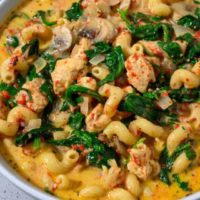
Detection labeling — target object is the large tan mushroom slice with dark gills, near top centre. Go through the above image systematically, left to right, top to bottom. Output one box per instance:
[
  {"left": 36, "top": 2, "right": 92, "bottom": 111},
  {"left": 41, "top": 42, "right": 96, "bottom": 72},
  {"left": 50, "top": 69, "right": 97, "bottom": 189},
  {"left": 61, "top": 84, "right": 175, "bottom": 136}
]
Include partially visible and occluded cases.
[{"left": 79, "top": 17, "right": 117, "bottom": 42}]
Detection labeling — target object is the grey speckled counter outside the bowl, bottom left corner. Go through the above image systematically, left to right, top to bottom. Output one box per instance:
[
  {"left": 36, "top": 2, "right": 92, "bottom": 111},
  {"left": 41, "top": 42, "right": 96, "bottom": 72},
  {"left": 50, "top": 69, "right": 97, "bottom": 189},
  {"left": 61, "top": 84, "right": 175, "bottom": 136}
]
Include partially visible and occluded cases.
[{"left": 0, "top": 174, "right": 36, "bottom": 200}]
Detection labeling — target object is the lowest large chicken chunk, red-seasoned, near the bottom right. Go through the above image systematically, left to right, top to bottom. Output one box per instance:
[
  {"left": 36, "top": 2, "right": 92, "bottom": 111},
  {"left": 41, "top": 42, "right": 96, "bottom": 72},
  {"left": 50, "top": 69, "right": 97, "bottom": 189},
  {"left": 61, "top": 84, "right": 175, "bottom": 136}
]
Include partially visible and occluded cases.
[{"left": 127, "top": 143, "right": 160, "bottom": 180}]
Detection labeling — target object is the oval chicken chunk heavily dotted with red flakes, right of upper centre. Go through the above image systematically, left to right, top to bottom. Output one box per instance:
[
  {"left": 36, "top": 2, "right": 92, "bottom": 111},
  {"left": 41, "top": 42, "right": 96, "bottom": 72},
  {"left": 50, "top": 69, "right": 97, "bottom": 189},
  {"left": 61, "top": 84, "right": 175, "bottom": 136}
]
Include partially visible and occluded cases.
[{"left": 125, "top": 54, "right": 155, "bottom": 93}]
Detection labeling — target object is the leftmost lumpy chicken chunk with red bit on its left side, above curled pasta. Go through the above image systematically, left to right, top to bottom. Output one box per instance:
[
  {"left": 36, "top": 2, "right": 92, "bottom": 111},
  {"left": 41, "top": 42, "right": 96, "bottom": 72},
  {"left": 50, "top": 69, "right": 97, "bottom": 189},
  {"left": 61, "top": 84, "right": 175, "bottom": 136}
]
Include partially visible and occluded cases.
[{"left": 16, "top": 78, "right": 48, "bottom": 113}]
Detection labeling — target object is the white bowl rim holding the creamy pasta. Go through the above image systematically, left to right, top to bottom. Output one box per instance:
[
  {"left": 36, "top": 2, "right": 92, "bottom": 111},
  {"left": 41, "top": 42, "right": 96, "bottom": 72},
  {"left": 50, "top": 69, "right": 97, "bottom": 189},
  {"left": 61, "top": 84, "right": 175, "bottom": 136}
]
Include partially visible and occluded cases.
[{"left": 0, "top": 0, "right": 200, "bottom": 200}]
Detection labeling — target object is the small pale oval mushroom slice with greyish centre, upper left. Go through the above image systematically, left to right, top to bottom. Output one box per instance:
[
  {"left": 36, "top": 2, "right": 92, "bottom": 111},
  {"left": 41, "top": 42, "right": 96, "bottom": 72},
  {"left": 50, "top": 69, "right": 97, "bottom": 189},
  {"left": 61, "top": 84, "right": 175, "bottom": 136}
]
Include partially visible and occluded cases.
[{"left": 53, "top": 25, "right": 72, "bottom": 51}]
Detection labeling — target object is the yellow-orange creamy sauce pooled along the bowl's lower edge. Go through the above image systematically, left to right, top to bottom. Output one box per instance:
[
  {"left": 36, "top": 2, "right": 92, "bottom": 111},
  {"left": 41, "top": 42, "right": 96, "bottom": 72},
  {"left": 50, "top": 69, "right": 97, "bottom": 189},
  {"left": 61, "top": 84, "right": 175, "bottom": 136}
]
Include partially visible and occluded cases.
[{"left": 0, "top": 139, "right": 200, "bottom": 200}]
